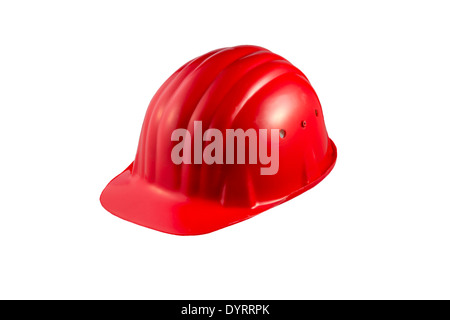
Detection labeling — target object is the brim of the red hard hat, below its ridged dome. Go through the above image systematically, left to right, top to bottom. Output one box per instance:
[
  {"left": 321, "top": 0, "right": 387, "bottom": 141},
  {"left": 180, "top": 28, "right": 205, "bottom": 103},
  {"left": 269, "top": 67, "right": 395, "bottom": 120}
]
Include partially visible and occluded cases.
[{"left": 100, "top": 139, "right": 337, "bottom": 235}]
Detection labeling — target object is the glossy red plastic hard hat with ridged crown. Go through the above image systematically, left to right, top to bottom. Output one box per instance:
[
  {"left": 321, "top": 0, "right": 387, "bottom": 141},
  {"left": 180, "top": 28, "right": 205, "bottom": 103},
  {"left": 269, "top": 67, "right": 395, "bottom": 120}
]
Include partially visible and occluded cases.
[{"left": 100, "top": 46, "right": 337, "bottom": 235}]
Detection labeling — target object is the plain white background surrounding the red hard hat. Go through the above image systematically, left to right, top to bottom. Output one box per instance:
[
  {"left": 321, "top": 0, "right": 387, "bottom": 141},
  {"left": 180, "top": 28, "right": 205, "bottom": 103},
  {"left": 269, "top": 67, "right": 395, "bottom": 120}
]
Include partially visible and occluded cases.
[{"left": 0, "top": 1, "right": 450, "bottom": 299}]
